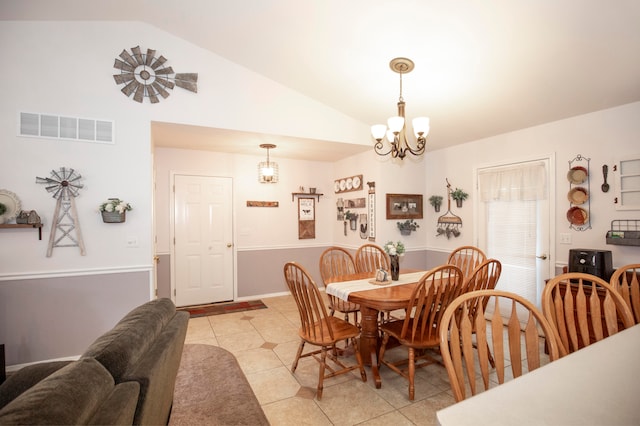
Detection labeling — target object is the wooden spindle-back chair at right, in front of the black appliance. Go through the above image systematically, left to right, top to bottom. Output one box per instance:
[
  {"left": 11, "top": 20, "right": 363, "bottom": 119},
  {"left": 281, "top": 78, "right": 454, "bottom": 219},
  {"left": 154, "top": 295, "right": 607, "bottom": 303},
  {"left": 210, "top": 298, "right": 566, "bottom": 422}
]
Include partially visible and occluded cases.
[{"left": 542, "top": 272, "right": 634, "bottom": 356}]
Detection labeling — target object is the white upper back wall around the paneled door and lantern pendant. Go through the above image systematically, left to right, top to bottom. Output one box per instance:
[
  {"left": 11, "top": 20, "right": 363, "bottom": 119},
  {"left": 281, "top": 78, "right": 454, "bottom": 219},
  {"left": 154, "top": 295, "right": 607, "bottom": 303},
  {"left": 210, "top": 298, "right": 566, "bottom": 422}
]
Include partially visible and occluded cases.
[{"left": 155, "top": 148, "right": 335, "bottom": 253}]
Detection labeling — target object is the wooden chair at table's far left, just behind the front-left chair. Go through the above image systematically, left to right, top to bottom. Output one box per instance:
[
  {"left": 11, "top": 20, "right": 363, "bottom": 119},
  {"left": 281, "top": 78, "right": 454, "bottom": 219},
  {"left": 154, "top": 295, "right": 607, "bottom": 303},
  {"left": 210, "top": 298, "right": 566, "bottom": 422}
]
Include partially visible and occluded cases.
[{"left": 319, "top": 246, "right": 360, "bottom": 324}]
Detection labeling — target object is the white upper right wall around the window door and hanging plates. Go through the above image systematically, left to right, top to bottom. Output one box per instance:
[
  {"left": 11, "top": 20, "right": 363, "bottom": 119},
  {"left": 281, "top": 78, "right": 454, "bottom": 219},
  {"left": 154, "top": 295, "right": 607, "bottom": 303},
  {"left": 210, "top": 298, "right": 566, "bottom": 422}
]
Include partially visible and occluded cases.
[{"left": 425, "top": 102, "right": 640, "bottom": 266}]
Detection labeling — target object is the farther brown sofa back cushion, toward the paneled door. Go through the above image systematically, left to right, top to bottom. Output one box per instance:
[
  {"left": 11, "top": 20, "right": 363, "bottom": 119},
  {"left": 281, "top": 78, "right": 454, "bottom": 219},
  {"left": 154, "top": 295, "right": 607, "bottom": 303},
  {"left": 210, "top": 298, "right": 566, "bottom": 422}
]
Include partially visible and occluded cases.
[{"left": 82, "top": 298, "right": 176, "bottom": 383}]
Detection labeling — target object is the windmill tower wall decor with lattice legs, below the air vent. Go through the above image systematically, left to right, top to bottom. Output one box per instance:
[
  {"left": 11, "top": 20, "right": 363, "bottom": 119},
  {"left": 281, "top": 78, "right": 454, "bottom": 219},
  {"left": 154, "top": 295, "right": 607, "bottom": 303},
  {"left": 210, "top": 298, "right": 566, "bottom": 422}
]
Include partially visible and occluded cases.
[{"left": 36, "top": 167, "right": 85, "bottom": 257}]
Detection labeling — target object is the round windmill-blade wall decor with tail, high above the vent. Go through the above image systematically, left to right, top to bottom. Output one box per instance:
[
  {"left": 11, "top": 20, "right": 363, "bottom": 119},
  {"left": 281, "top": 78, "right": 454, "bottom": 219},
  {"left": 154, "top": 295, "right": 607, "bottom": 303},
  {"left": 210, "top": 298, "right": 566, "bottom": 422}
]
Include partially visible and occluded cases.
[{"left": 113, "top": 46, "right": 198, "bottom": 104}]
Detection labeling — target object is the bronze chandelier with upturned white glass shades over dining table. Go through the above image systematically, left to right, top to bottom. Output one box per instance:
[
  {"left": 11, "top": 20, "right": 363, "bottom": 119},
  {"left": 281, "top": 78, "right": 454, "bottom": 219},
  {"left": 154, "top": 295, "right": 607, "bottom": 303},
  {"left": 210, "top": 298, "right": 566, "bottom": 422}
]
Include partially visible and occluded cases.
[{"left": 371, "top": 58, "right": 429, "bottom": 160}]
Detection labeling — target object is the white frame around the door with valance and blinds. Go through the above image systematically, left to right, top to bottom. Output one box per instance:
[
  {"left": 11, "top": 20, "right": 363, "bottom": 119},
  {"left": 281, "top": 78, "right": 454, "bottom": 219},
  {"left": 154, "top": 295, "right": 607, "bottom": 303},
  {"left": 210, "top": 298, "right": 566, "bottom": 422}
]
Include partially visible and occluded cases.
[{"left": 473, "top": 152, "right": 557, "bottom": 306}]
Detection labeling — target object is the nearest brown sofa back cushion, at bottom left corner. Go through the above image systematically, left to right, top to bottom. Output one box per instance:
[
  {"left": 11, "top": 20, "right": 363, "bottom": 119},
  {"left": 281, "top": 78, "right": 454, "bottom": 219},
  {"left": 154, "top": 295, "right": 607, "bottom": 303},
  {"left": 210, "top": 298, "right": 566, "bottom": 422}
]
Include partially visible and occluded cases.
[{"left": 0, "top": 358, "right": 139, "bottom": 425}]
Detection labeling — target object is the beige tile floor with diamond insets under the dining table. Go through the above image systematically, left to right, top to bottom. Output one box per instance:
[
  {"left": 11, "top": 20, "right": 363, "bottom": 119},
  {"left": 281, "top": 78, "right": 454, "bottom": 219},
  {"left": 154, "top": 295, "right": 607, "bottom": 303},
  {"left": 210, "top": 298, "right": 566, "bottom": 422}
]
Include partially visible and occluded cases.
[{"left": 186, "top": 296, "right": 455, "bottom": 426}]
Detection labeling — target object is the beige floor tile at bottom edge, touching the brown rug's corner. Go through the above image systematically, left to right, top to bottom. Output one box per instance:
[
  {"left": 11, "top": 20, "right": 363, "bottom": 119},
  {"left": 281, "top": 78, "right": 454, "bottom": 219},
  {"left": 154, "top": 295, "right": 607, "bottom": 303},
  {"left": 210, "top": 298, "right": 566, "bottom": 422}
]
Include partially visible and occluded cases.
[{"left": 262, "top": 398, "right": 332, "bottom": 426}]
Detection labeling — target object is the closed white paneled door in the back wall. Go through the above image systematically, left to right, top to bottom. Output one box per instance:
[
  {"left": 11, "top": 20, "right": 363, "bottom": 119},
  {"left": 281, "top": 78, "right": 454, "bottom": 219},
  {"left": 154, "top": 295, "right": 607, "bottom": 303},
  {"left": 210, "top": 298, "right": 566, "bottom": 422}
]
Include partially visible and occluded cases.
[{"left": 173, "top": 174, "right": 234, "bottom": 306}]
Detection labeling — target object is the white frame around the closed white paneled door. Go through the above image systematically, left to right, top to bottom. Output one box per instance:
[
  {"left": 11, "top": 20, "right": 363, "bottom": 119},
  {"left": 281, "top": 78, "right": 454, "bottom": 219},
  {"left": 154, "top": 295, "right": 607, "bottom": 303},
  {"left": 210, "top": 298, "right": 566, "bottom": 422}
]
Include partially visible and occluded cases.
[{"left": 169, "top": 170, "right": 238, "bottom": 304}]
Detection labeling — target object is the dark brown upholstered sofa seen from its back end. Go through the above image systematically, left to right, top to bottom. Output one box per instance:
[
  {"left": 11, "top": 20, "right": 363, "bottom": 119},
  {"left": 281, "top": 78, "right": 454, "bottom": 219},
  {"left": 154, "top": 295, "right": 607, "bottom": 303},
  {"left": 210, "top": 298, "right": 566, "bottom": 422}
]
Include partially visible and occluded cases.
[{"left": 0, "top": 299, "right": 189, "bottom": 425}]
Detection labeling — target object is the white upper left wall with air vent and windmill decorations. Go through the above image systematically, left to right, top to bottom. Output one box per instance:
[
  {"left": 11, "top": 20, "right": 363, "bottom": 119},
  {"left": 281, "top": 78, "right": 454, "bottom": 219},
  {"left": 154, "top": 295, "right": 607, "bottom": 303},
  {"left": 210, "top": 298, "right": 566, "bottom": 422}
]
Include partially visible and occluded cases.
[{"left": 0, "top": 21, "right": 367, "bottom": 279}]
